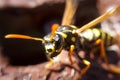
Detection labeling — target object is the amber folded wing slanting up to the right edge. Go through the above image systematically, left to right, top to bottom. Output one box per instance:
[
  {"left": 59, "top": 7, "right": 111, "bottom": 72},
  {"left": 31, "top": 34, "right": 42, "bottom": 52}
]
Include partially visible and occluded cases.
[{"left": 76, "top": 6, "right": 120, "bottom": 33}]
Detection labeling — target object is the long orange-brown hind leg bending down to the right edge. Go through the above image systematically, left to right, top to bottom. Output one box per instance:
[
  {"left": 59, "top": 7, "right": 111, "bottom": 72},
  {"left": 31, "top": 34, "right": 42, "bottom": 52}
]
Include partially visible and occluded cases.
[{"left": 95, "top": 39, "right": 120, "bottom": 74}]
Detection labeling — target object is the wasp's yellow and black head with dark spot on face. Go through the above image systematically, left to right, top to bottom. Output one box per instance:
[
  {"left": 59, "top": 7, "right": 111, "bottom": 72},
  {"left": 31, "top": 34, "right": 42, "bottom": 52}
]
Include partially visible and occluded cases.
[{"left": 44, "top": 34, "right": 64, "bottom": 58}]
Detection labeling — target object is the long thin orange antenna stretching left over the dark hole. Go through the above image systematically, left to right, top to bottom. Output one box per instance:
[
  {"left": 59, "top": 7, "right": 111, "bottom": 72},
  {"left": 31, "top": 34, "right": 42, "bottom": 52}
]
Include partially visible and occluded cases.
[{"left": 5, "top": 34, "right": 44, "bottom": 42}]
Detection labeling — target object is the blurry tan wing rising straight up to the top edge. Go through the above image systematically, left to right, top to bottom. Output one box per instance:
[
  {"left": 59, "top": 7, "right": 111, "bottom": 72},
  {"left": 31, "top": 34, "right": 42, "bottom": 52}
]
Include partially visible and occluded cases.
[{"left": 62, "top": 0, "right": 79, "bottom": 25}]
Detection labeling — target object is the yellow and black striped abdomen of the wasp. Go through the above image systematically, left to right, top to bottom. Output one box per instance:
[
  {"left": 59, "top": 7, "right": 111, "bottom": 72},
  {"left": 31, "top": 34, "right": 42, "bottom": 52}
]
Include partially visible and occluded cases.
[{"left": 80, "top": 28, "right": 114, "bottom": 47}]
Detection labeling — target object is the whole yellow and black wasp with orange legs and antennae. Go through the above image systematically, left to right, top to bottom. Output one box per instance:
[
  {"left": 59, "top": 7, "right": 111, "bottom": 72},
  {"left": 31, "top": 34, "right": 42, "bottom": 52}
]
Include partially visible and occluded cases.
[{"left": 5, "top": 0, "right": 120, "bottom": 75}]
